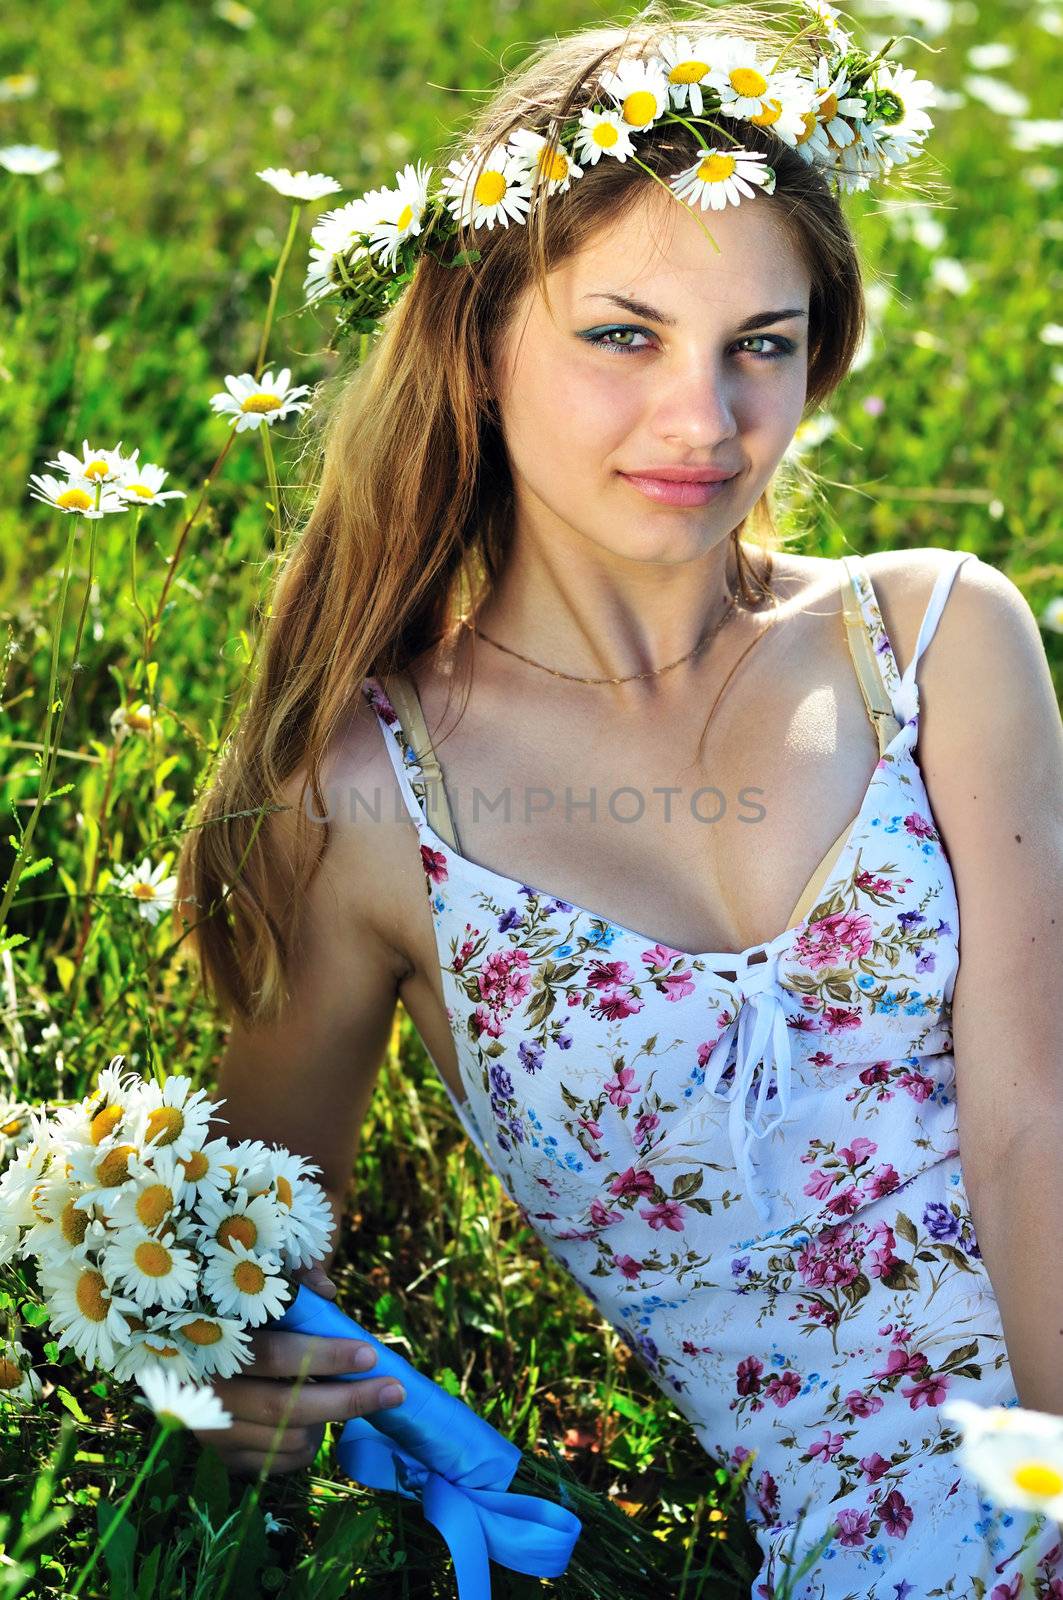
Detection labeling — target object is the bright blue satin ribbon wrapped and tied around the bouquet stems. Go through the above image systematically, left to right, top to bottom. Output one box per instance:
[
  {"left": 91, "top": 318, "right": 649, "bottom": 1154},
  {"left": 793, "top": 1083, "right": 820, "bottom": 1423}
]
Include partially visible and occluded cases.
[{"left": 269, "top": 1283, "right": 583, "bottom": 1600}]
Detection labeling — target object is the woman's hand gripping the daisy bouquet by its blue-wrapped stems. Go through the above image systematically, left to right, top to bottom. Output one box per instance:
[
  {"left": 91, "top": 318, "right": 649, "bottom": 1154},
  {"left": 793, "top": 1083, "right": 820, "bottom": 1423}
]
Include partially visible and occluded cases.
[{"left": 192, "top": 1266, "right": 405, "bottom": 1477}]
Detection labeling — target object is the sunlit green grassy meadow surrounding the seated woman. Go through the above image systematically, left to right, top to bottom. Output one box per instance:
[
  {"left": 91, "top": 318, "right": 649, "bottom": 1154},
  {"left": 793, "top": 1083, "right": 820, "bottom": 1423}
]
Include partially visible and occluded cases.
[{"left": 0, "top": 0, "right": 1063, "bottom": 1600}]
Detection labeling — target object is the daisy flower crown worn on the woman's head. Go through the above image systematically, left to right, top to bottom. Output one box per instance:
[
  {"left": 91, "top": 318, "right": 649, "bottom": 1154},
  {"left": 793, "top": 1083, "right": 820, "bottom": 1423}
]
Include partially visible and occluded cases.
[{"left": 304, "top": 0, "right": 933, "bottom": 334}]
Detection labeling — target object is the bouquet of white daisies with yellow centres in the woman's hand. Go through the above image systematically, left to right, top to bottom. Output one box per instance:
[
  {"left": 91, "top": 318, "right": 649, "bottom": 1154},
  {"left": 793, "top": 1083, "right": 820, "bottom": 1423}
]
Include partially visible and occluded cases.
[{"left": 0, "top": 1056, "right": 335, "bottom": 1382}]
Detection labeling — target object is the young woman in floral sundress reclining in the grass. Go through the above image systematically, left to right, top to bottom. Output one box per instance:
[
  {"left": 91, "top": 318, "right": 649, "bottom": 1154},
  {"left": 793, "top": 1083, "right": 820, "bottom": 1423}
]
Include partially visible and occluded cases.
[{"left": 179, "top": 6, "right": 1063, "bottom": 1600}]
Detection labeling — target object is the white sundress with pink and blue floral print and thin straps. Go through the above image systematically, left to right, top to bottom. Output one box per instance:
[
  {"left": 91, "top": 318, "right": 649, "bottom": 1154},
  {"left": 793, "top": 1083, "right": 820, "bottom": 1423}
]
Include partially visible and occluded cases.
[{"left": 362, "top": 550, "right": 1063, "bottom": 1600}]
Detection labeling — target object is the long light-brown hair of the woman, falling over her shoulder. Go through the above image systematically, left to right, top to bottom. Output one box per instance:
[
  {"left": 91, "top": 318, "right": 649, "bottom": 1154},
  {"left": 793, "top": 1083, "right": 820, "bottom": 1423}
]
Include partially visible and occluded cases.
[{"left": 178, "top": 0, "right": 864, "bottom": 1022}]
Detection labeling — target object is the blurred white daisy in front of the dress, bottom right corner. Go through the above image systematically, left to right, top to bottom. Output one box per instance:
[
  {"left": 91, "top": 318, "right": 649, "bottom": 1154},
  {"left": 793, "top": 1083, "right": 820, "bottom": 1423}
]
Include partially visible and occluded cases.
[{"left": 941, "top": 1398, "right": 1063, "bottom": 1522}]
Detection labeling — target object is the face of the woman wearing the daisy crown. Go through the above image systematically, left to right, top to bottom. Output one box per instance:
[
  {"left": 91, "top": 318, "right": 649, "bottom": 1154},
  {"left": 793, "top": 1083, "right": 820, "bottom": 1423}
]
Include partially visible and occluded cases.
[{"left": 493, "top": 187, "right": 810, "bottom": 562}]
